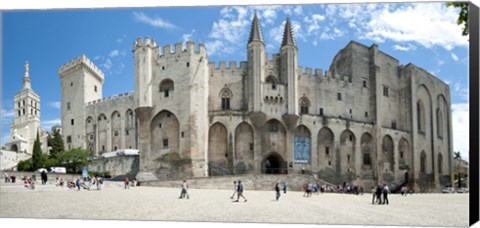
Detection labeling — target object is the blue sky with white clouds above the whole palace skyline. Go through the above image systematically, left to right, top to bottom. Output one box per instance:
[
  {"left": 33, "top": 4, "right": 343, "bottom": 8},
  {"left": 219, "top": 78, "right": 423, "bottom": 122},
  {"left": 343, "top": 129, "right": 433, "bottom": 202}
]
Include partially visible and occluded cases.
[{"left": 0, "top": 3, "right": 469, "bottom": 158}]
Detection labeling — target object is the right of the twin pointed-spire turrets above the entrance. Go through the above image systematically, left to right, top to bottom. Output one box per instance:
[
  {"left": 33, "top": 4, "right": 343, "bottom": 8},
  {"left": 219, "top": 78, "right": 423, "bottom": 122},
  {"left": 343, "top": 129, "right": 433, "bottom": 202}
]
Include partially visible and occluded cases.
[{"left": 280, "top": 17, "right": 298, "bottom": 114}]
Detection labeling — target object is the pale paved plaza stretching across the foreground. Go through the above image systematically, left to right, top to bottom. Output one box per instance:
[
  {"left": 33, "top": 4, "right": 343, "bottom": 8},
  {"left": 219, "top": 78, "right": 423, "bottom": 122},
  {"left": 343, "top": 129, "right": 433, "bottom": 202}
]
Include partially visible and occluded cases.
[{"left": 0, "top": 182, "right": 469, "bottom": 227}]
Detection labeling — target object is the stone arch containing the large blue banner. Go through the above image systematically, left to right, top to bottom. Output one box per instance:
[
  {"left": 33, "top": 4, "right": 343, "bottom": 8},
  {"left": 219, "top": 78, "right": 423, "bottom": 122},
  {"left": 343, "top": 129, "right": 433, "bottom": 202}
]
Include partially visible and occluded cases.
[{"left": 293, "top": 125, "right": 312, "bottom": 163}]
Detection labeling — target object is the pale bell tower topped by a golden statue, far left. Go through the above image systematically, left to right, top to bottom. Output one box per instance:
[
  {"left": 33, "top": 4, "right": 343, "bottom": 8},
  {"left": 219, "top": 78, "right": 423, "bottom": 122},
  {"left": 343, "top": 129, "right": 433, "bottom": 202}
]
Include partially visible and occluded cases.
[{"left": 6, "top": 62, "right": 47, "bottom": 154}]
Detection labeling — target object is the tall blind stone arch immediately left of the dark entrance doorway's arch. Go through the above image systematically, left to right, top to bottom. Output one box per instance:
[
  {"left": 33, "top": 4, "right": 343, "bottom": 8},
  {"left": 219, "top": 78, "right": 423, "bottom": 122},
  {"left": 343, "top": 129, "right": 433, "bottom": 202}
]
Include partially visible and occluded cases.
[{"left": 235, "top": 122, "right": 254, "bottom": 174}]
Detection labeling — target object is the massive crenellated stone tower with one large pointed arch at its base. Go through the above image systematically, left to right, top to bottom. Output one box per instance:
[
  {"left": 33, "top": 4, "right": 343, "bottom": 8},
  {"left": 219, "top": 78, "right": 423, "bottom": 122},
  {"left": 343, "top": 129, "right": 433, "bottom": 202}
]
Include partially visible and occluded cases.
[{"left": 134, "top": 36, "right": 208, "bottom": 180}]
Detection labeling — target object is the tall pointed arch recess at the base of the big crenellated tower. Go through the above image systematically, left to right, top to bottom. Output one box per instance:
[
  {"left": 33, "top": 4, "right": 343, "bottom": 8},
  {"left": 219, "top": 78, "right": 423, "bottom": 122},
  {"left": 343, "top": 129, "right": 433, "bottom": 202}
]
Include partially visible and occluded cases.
[{"left": 150, "top": 110, "right": 180, "bottom": 160}]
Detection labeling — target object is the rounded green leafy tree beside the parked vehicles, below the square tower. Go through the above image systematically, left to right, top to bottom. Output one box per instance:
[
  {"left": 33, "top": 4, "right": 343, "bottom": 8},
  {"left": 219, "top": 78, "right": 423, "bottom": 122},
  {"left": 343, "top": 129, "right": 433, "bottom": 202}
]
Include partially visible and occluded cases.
[{"left": 56, "top": 148, "right": 90, "bottom": 173}]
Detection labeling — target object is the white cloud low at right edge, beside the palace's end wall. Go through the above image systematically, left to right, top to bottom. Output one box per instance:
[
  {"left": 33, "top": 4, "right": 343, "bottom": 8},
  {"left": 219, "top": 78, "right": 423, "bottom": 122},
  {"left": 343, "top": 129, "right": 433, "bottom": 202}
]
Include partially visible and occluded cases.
[{"left": 452, "top": 103, "right": 470, "bottom": 160}]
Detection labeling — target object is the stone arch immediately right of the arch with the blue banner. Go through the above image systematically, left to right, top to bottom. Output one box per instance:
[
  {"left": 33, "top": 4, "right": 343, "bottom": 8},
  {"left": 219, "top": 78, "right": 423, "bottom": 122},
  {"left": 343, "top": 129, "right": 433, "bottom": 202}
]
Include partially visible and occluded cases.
[{"left": 317, "top": 127, "right": 335, "bottom": 167}]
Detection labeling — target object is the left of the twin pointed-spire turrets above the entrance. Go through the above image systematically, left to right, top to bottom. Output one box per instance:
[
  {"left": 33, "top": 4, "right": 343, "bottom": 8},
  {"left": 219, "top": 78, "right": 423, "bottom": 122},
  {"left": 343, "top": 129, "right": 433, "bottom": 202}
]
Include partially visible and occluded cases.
[{"left": 246, "top": 12, "right": 265, "bottom": 112}]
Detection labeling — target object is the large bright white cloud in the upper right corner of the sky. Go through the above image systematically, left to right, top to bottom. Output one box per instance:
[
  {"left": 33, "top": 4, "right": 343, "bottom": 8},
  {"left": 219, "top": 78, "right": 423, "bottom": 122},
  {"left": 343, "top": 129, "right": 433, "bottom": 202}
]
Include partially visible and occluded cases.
[{"left": 360, "top": 3, "right": 468, "bottom": 50}]
